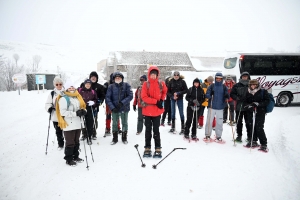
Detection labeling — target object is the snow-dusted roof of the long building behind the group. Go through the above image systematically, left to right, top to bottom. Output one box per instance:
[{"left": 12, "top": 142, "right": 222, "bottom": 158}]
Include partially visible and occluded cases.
[{"left": 107, "top": 51, "right": 193, "bottom": 67}]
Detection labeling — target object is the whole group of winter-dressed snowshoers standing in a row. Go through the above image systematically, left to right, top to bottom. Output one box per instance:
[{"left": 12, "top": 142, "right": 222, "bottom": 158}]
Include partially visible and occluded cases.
[{"left": 45, "top": 66, "right": 269, "bottom": 166}]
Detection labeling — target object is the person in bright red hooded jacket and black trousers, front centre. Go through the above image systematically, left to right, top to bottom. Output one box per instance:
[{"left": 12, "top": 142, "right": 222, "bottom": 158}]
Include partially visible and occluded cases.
[{"left": 141, "top": 66, "right": 168, "bottom": 158}]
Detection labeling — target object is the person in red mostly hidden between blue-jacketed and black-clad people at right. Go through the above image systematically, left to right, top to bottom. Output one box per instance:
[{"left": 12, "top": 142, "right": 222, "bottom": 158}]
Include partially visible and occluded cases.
[{"left": 223, "top": 76, "right": 235, "bottom": 126}]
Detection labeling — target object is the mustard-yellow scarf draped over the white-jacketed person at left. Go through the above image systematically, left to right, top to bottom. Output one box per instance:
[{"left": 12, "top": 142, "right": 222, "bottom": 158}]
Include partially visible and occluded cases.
[{"left": 55, "top": 90, "right": 86, "bottom": 129}]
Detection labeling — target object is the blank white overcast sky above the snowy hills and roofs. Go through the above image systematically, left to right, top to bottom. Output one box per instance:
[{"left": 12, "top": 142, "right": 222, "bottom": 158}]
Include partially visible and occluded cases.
[{"left": 0, "top": 0, "right": 300, "bottom": 51}]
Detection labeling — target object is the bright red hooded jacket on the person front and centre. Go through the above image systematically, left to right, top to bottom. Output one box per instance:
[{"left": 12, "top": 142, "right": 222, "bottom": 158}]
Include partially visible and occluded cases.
[{"left": 141, "top": 66, "right": 168, "bottom": 117}]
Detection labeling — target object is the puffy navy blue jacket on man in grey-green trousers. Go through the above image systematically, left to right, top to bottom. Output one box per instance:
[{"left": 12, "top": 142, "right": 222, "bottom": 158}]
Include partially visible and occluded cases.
[{"left": 105, "top": 81, "right": 133, "bottom": 112}]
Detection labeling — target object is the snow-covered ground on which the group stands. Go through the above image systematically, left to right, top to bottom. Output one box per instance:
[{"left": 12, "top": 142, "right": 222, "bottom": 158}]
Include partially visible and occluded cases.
[{"left": 0, "top": 91, "right": 300, "bottom": 200}]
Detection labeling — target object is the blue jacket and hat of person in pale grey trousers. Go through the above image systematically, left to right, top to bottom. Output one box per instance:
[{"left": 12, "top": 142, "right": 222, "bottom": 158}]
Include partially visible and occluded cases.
[{"left": 205, "top": 72, "right": 229, "bottom": 110}]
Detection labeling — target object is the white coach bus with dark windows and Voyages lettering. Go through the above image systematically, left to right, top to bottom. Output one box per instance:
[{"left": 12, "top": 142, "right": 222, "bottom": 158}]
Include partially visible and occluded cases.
[{"left": 223, "top": 53, "right": 300, "bottom": 106}]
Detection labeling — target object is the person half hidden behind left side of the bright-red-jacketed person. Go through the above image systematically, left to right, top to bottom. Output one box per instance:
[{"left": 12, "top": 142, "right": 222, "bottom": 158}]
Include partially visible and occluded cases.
[{"left": 133, "top": 75, "right": 147, "bottom": 135}]
